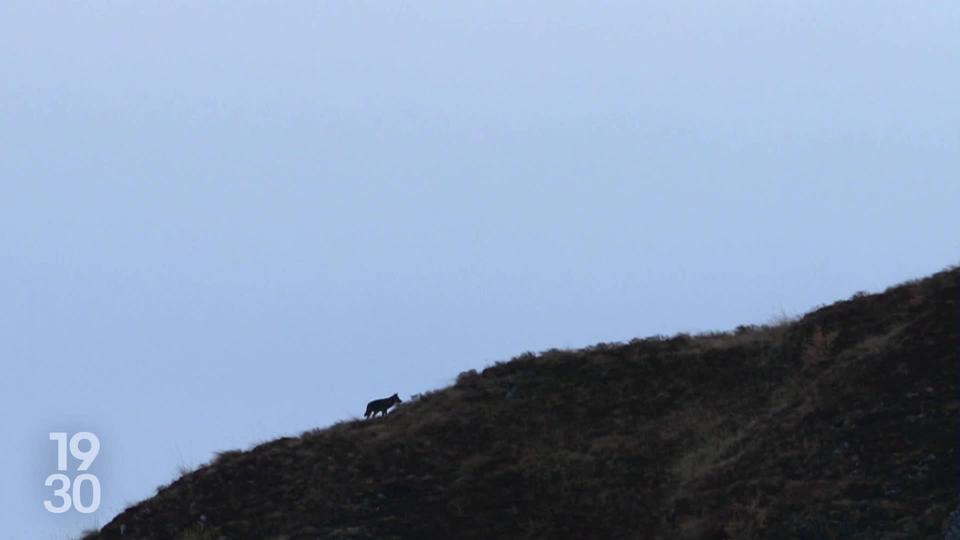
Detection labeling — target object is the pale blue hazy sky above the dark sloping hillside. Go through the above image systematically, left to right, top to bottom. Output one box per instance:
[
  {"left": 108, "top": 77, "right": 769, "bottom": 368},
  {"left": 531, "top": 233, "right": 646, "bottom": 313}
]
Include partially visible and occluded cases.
[{"left": 0, "top": 0, "right": 960, "bottom": 540}]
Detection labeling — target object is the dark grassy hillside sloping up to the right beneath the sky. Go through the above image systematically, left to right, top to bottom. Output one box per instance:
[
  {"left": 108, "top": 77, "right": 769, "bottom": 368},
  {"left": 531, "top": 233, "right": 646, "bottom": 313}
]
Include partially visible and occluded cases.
[{"left": 85, "top": 268, "right": 960, "bottom": 540}]
